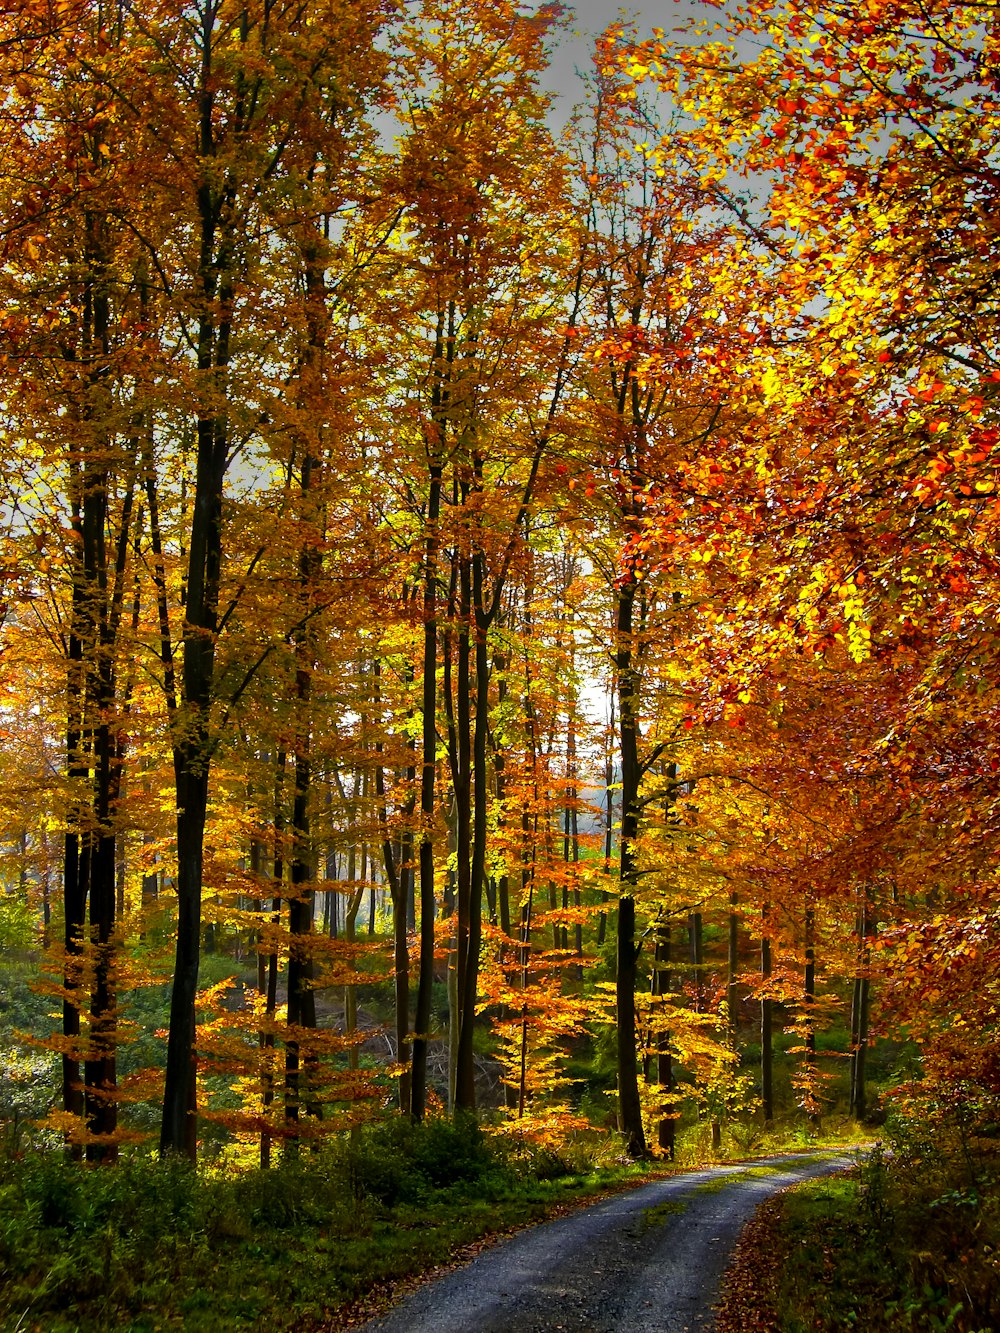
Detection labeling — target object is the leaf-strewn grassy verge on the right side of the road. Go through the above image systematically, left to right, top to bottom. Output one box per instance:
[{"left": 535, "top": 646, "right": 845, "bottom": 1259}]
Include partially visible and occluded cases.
[{"left": 719, "top": 1116, "right": 1000, "bottom": 1333}]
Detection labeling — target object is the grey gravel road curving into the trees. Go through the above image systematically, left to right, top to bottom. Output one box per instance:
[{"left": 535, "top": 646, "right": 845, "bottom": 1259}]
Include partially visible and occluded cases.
[{"left": 364, "top": 1156, "right": 853, "bottom": 1333}]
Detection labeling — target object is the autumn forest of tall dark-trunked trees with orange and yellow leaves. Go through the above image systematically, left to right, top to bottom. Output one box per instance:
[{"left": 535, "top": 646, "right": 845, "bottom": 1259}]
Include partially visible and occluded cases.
[{"left": 0, "top": 0, "right": 1000, "bottom": 1328}]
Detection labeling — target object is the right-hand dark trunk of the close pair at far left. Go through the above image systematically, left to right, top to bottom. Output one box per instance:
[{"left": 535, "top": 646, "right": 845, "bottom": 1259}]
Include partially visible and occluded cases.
[{"left": 63, "top": 205, "right": 139, "bottom": 1162}]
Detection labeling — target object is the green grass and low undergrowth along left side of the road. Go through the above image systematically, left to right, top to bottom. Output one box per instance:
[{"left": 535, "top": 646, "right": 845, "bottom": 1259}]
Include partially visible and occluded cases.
[{"left": 0, "top": 1120, "right": 658, "bottom": 1333}]
